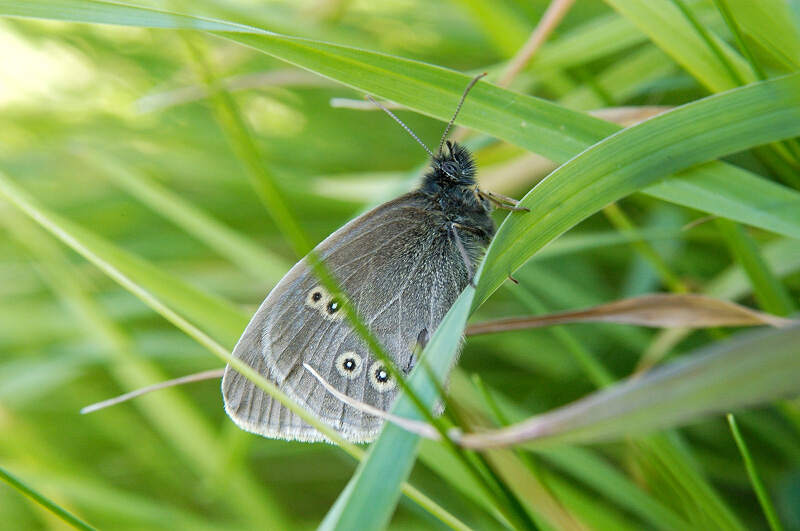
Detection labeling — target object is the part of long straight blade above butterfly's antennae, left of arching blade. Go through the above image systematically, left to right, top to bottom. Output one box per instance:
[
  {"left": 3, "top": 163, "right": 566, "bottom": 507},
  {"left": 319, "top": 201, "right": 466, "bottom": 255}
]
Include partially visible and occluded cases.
[{"left": 0, "top": 0, "right": 618, "bottom": 162}]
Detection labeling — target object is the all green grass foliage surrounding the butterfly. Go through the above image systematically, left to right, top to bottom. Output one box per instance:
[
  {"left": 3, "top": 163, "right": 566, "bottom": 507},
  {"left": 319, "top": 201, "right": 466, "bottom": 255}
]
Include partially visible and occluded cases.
[{"left": 0, "top": 0, "right": 800, "bottom": 529}]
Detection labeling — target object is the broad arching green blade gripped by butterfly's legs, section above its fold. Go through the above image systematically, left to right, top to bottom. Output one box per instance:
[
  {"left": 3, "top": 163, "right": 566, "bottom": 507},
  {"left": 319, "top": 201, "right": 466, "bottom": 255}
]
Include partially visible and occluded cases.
[{"left": 476, "top": 75, "right": 800, "bottom": 304}]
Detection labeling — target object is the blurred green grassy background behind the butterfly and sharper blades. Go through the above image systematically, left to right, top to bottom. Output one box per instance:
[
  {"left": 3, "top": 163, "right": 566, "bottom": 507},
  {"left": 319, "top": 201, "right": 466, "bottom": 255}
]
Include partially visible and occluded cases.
[{"left": 0, "top": 0, "right": 800, "bottom": 529}]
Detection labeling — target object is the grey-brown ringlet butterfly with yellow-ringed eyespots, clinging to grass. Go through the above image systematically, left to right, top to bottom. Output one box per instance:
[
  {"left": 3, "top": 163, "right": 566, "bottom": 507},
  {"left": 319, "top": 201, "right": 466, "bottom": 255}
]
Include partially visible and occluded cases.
[{"left": 222, "top": 74, "right": 518, "bottom": 442}]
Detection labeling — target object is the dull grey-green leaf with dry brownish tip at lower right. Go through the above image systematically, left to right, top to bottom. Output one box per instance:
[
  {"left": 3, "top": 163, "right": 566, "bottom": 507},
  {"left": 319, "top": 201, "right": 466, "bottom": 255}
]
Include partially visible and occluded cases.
[{"left": 460, "top": 325, "right": 800, "bottom": 448}]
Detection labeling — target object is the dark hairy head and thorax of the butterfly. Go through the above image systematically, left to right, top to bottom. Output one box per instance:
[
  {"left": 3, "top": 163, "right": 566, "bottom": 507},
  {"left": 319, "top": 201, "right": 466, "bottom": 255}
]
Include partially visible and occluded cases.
[{"left": 419, "top": 142, "right": 495, "bottom": 241}]
